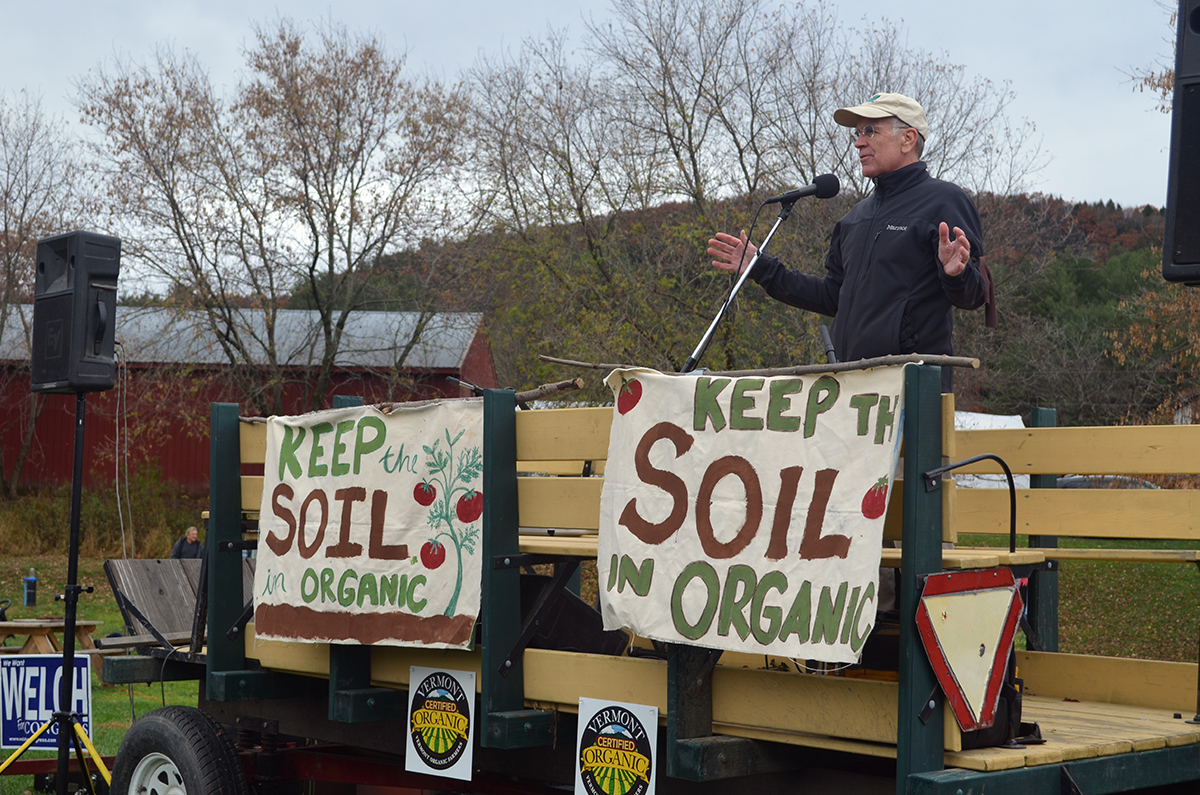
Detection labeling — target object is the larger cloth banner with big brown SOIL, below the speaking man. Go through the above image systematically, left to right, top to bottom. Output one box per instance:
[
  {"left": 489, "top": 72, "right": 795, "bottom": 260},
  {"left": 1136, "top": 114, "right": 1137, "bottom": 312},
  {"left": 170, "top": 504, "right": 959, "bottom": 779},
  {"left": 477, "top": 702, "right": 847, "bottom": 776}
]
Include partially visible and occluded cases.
[{"left": 598, "top": 367, "right": 904, "bottom": 663}]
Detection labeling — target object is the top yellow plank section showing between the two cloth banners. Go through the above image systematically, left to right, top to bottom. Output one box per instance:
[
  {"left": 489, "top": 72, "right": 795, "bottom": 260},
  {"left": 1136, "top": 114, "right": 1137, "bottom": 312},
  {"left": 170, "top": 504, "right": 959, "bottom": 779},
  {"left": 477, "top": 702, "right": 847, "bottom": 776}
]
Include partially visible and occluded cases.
[{"left": 516, "top": 407, "right": 613, "bottom": 461}]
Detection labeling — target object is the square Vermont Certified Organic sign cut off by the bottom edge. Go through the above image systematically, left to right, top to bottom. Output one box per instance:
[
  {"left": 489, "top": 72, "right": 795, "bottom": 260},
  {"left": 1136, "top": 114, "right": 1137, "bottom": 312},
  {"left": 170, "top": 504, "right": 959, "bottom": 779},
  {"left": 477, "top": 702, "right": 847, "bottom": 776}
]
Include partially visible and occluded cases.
[{"left": 575, "top": 699, "right": 659, "bottom": 795}]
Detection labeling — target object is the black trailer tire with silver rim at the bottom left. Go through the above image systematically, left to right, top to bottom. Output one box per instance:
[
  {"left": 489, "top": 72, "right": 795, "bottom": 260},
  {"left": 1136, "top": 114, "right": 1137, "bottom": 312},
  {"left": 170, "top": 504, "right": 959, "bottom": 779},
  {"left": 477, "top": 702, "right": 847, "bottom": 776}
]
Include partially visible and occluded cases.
[{"left": 112, "top": 706, "right": 250, "bottom": 795}]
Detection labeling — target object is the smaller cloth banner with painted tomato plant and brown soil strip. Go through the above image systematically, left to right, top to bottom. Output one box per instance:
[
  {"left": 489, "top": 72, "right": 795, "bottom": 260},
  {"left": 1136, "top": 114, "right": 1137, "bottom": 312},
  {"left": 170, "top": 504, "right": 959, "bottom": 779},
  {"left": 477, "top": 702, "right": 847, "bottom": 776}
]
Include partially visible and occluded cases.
[{"left": 254, "top": 400, "right": 484, "bottom": 648}]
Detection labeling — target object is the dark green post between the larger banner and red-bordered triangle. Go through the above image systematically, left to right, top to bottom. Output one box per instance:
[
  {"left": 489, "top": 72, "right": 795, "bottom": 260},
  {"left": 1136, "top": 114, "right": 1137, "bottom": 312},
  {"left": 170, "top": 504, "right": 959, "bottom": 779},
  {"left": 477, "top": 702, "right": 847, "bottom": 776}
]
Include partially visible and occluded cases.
[{"left": 896, "top": 365, "right": 943, "bottom": 795}]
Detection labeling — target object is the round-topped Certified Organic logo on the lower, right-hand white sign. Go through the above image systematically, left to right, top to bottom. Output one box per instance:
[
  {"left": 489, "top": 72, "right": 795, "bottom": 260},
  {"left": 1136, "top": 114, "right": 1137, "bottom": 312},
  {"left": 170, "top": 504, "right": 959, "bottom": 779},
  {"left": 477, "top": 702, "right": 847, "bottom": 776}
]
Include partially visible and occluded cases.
[{"left": 580, "top": 706, "right": 654, "bottom": 795}]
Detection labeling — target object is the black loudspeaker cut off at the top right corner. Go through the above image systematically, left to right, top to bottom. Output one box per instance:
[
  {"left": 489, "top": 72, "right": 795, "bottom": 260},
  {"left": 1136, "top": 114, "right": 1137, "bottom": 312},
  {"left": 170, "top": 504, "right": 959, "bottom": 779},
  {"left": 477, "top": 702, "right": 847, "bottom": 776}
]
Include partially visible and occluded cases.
[{"left": 1163, "top": 0, "right": 1200, "bottom": 285}]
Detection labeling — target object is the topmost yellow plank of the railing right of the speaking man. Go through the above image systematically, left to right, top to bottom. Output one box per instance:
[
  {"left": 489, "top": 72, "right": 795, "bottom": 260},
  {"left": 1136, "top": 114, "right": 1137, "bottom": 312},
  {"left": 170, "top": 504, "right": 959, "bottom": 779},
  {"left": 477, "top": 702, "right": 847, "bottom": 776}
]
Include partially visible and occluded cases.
[{"left": 954, "top": 425, "right": 1200, "bottom": 474}]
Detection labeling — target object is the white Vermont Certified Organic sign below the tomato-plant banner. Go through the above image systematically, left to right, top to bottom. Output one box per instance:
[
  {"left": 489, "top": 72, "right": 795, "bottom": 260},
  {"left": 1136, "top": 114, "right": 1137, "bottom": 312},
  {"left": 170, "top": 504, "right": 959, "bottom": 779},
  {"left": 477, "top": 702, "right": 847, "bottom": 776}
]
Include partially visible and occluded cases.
[{"left": 404, "top": 665, "right": 475, "bottom": 781}]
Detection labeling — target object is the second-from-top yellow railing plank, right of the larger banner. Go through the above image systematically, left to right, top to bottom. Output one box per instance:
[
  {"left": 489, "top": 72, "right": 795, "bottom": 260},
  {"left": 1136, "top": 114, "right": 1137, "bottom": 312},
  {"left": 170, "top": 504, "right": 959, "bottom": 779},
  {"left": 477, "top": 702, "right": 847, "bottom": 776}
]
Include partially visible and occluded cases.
[{"left": 958, "top": 492, "right": 1200, "bottom": 540}]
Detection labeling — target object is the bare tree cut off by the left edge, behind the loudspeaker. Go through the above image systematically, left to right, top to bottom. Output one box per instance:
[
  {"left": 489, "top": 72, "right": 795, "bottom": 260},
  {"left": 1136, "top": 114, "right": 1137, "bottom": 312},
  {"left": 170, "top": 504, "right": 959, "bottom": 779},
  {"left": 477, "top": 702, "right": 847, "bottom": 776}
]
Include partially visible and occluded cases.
[{"left": 0, "top": 96, "right": 80, "bottom": 498}]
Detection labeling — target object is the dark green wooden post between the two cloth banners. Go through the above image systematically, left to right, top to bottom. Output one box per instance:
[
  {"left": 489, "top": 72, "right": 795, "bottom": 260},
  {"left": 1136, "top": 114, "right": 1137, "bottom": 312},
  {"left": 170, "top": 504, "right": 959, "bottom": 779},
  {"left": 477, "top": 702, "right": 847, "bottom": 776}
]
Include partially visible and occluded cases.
[{"left": 479, "top": 389, "right": 554, "bottom": 748}]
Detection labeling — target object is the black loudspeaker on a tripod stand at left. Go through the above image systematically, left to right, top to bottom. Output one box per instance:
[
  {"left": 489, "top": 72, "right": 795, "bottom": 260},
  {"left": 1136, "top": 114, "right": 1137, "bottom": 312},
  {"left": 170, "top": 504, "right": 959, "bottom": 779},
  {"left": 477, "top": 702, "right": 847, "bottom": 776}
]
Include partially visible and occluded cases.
[{"left": 30, "top": 232, "right": 121, "bottom": 393}]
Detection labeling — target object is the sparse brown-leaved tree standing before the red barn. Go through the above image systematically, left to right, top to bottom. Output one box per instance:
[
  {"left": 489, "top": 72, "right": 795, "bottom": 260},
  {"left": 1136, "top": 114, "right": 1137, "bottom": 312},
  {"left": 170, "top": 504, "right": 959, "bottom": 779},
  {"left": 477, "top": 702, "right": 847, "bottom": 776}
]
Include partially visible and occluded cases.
[{"left": 78, "top": 19, "right": 464, "bottom": 414}]
